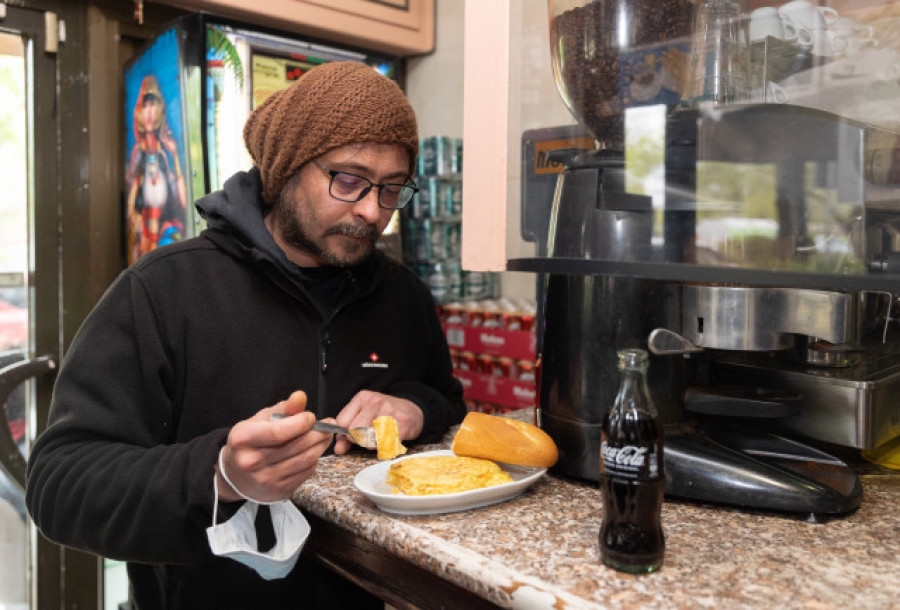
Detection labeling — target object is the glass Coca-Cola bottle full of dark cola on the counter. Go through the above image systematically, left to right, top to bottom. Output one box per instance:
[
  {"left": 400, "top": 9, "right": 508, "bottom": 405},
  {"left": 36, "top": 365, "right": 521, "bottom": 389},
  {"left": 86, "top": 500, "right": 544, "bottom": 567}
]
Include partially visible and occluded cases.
[{"left": 600, "top": 349, "right": 665, "bottom": 574}]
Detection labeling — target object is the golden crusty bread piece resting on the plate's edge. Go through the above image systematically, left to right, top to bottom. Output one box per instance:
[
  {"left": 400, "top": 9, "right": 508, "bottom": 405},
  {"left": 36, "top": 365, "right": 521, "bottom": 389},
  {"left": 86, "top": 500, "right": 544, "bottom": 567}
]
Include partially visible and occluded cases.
[{"left": 451, "top": 411, "right": 559, "bottom": 468}]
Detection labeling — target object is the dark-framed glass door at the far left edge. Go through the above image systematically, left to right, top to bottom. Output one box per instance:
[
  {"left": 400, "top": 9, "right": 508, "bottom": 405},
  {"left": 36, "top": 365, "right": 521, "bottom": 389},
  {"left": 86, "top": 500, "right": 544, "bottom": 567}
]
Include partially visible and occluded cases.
[{"left": 0, "top": 4, "right": 98, "bottom": 610}]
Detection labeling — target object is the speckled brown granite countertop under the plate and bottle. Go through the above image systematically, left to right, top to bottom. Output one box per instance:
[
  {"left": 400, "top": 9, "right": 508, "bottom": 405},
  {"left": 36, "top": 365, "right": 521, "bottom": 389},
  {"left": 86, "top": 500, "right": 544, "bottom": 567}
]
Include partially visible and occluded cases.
[{"left": 294, "top": 418, "right": 900, "bottom": 610}]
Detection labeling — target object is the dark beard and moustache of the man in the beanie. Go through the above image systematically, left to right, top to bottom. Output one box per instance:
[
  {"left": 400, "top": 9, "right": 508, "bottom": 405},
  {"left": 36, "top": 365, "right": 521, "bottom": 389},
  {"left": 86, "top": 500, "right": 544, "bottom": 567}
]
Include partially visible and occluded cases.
[{"left": 275, "top": 189, "right": 378, "bottom": 267}]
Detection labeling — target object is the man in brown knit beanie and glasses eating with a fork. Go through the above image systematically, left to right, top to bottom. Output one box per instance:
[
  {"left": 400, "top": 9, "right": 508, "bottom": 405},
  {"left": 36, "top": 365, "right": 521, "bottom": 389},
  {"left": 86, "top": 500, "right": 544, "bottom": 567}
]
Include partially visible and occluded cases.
[{"left": 27, "top": 62, "right": 465, "bottom": 609}]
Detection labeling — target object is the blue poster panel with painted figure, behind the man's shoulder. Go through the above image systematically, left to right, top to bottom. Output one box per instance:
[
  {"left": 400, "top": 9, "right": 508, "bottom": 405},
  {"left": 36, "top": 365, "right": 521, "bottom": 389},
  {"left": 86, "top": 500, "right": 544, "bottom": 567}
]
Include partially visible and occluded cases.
[{"left": 124, "top": 28, "right": 190, "bottom": 264}]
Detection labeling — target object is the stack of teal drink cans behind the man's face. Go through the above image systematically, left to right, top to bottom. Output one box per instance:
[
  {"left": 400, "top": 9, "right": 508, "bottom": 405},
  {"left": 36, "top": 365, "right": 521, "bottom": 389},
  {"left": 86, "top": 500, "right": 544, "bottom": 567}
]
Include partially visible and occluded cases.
[{"left": 401, "top": 136, "right": 500, "bottom": 304}]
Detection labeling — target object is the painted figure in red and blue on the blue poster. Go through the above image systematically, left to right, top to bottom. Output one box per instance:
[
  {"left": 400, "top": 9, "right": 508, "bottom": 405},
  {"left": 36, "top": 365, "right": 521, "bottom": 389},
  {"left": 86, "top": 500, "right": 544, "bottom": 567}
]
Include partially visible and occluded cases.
[{"left": 126, "top": 74, "right": 187, "bottom": 262}]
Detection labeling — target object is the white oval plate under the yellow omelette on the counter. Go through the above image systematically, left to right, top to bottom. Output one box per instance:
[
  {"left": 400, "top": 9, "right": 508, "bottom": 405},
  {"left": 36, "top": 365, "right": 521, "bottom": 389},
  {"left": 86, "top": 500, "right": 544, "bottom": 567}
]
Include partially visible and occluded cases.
[{"left": 353, "top": 450, "right": 547, "bottom": 515}]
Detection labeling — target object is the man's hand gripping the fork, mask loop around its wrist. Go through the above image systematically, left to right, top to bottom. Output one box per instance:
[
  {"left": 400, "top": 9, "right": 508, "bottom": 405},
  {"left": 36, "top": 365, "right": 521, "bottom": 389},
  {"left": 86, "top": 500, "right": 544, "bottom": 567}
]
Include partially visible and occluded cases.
[{"left": 216, "top": 391, "right": 331, "bottom": 502}]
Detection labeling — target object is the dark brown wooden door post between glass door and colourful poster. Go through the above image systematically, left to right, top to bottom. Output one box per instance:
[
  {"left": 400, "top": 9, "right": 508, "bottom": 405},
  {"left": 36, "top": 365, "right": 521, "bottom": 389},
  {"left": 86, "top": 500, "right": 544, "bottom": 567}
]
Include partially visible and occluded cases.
[{"left": 9, "top": 0, "right": 188, "bottom": 610}]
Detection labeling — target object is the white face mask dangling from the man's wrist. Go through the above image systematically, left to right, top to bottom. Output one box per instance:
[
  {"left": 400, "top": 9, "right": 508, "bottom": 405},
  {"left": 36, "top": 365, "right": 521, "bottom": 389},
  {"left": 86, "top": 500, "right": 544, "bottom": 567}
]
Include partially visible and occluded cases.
[{"left": 206, "top": 478, "right": 310, "bottom": 580}]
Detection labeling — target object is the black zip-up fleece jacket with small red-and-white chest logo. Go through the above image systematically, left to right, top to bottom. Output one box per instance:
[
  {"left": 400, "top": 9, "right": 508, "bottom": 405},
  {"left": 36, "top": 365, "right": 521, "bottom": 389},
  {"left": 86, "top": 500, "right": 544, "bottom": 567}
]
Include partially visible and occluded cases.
[{"left": 26, "top": 169, "right": 465, "bottom": 608}]
